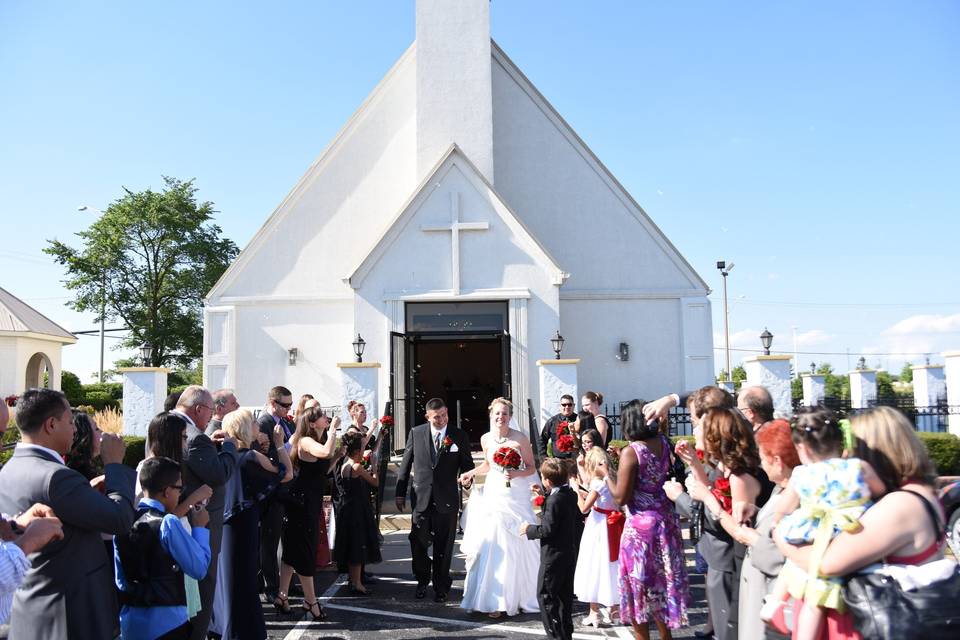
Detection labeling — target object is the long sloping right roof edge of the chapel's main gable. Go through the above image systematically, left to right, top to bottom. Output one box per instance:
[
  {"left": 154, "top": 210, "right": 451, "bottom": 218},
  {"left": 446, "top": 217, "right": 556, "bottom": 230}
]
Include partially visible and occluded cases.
[{"left": 490, "top": 39, "right": 710, "bottom": 293}]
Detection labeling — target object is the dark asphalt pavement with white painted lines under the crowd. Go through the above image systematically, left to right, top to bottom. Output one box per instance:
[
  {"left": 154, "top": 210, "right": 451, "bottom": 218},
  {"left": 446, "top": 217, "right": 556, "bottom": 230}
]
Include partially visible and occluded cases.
[{"left": 264, "top": 530, "right": 706, "bottom": 640}]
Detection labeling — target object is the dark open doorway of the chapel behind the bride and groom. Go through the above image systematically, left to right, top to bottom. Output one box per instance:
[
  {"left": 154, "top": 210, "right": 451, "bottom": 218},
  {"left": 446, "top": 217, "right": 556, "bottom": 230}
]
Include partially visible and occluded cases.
[{"left": 413, "top": 336, "right": 509, "bottom": 446}]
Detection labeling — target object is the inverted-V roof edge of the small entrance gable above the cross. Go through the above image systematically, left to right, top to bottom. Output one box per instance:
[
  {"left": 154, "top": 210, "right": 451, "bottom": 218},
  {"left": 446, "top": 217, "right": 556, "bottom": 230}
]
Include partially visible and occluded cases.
[{"left": 343, "top": 144, "right": 570, "bottom": 289}]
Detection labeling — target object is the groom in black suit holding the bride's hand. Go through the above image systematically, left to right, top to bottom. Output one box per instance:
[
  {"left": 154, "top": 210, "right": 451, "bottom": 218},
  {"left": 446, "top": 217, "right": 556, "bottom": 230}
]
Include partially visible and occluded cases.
[{"left": 396, "top": 398, "right": 473, "bottom": 602}]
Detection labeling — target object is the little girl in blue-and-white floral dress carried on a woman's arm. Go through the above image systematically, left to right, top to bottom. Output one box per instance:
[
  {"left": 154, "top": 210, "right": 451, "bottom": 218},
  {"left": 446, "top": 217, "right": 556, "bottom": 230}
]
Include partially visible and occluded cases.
[{"left": 760, "top": 408, "right": 886, "bottom": 640}]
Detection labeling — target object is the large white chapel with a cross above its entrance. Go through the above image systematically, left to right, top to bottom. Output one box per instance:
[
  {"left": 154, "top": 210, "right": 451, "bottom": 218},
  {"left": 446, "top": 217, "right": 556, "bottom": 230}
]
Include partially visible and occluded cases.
[{"left": 204, "top": 0, "right": 713, "bottom": 446}]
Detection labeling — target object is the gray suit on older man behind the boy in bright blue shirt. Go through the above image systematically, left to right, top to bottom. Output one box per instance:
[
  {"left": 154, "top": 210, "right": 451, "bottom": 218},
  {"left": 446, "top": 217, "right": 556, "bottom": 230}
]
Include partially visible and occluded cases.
[{"left": 182, "top": 422, "right": 237, "bottom": 640}]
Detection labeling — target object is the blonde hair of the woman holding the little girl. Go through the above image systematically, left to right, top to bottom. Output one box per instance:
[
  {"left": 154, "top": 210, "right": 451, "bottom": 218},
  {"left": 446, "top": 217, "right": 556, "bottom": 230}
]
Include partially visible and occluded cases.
[{"left": 850, "top": 407, "right": 937, "bottom": 489}]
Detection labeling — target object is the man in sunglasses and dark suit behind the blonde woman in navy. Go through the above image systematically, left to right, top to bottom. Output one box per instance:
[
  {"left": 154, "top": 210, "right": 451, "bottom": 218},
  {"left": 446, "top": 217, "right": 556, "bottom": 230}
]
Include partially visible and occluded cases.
[{"left": 257, "top": 387, "right": 293, "bottom": 601}]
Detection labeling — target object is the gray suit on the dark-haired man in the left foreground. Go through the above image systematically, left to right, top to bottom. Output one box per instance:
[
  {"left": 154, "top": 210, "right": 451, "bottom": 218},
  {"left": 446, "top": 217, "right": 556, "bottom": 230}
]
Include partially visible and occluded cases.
[{"left": 0, "top": 447, "right": 135, "bottom": 640}]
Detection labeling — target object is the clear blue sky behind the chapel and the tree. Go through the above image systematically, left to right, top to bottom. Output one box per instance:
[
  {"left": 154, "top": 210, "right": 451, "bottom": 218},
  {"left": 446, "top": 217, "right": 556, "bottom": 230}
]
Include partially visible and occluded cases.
[{"left": 0, "top": 0, "right": 960, "bottom": 380}]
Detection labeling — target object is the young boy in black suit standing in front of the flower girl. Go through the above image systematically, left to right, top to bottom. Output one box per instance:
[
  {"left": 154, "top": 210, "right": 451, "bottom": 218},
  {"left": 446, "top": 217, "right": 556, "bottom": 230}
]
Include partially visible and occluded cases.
[{"left": 520, "top": 458, "right": 582, "bottom": 640}]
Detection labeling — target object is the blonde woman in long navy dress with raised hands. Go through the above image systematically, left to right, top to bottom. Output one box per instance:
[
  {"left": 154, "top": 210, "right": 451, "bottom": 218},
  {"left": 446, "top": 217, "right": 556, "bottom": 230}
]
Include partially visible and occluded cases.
[{"left": 210, "top": 409, "right": 293, "bottom": 640}]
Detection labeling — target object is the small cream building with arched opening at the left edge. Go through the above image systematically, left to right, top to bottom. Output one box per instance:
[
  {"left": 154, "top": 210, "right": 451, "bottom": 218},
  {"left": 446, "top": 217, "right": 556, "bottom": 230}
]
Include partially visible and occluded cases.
[{"left": 0, "top": 288, "right": 77, "bottom": 397}]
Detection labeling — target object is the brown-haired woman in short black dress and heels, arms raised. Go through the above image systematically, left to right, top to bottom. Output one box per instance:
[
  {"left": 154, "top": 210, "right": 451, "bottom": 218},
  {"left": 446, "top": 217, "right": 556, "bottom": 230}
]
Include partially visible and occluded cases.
[{"left": 273, "top": 406, "right": 340, "bottom": 620}]
